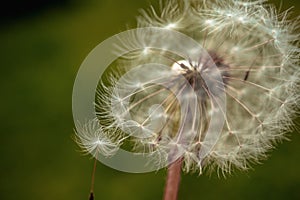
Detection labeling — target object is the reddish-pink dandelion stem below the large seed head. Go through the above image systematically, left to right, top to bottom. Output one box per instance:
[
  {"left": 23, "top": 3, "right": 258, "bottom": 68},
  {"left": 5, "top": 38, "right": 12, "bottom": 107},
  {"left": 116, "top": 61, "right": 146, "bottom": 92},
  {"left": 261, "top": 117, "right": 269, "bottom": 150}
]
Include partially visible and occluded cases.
[{"left": 164, "top": 158, "right": 182, "bottom": 200}]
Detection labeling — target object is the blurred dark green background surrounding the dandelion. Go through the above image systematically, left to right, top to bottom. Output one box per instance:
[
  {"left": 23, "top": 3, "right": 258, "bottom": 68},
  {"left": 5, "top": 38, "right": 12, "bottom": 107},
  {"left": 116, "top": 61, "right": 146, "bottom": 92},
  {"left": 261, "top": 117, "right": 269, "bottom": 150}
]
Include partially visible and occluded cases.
[{"left": 0, "top": 0, "right": 300, "bottom": 200}]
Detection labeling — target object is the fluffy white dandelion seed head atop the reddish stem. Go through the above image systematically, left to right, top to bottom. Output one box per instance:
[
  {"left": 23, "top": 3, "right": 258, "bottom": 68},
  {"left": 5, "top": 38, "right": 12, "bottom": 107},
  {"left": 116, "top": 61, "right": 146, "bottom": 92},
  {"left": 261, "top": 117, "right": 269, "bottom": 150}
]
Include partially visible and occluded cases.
[{"left": 83, "top": 0, "right": 300, "bottom": 174}]
